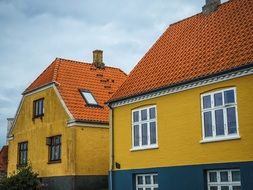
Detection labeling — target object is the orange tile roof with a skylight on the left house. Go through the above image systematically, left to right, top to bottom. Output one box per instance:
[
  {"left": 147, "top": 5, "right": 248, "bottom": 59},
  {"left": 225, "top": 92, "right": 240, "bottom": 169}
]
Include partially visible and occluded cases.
[{"left": 24, "top": 58, "right": 127, "bottom": 123}]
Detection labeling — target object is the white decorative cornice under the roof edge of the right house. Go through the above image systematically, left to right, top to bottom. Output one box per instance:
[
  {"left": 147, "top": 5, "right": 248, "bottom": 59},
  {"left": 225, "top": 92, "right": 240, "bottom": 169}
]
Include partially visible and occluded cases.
[{"left": 111, "top": 67, "right": 253, "bottom": 108}]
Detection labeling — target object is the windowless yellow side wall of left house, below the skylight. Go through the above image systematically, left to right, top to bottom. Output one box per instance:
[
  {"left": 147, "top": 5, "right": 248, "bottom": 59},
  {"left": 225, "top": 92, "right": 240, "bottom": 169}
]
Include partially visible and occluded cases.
[{"left": 75, "top": 127, "right": 109, "bottom": 175}]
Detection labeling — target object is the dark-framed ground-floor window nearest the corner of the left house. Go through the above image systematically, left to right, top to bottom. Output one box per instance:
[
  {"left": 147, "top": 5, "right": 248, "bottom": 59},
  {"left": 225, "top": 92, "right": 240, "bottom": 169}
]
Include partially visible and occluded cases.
[{"left": 47, "top": 135, "right": 61, "bottom": 162}]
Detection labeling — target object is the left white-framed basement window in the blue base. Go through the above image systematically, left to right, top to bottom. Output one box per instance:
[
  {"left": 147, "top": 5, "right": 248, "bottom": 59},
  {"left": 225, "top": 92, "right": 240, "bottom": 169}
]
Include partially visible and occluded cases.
[{"left": 136, "top": 174, "right": 158, "bottom": 190}]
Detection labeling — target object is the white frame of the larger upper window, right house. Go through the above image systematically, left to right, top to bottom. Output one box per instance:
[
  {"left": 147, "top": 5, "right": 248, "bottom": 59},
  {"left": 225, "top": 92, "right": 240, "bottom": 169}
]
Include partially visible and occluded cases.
[{"left": 200, "top": 87, "right": 240, "bottom": 143}]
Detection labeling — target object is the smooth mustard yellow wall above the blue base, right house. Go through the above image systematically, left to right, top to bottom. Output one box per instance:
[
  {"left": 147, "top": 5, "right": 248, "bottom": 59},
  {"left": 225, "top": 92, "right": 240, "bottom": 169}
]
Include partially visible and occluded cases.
[{"left": 114, "top": 75, "right": 253, "bottom": 169}]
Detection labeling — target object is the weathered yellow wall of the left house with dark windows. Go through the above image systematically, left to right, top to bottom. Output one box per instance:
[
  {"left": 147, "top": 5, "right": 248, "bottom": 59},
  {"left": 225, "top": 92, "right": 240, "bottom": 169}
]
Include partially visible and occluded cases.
[{"left": 8, "top": 88, "right": 109, "bottom": 177}]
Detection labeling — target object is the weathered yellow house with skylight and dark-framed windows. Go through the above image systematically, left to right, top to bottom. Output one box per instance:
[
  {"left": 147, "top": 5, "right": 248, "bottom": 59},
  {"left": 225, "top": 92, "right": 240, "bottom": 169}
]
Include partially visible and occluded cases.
[{"left": 8, "top": 50, "right": 126, "bottom": 190}]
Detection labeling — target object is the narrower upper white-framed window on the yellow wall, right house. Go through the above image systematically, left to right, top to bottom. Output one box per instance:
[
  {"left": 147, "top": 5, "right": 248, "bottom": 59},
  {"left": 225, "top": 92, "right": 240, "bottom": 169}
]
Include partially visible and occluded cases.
[{"left": 132, "top": 106, "right": 157, "bottom": 149}]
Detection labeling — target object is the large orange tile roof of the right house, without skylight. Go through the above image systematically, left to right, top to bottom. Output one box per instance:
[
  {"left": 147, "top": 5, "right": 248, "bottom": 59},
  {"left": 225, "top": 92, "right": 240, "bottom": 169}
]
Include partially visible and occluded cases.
[{"left": 109, "top": 0, "right": 253, "bottom": 102}]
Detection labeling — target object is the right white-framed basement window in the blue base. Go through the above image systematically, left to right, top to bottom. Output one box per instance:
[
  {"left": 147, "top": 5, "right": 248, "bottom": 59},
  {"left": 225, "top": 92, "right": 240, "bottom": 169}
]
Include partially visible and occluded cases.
[{"left": 207, "top": 169, "right": 241, "bottom": 190}]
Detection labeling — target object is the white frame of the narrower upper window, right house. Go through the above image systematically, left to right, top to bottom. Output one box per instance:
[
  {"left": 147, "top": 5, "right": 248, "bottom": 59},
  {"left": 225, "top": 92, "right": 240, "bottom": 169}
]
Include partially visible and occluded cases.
[{"left": 130, "top": 105, "right": 158, "bottom": 151}]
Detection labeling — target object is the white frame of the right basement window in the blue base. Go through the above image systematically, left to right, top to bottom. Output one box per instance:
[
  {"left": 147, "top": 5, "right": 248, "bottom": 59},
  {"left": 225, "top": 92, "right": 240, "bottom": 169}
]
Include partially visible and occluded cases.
[{"left": 207, "top": 169, "right": 241, "bottom": 190}]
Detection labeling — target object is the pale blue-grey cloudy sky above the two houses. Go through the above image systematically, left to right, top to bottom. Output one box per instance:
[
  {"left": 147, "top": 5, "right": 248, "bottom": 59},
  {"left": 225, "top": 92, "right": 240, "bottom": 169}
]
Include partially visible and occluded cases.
[{"left": 0, "top": 0, "right": 215, "bottom": 146}]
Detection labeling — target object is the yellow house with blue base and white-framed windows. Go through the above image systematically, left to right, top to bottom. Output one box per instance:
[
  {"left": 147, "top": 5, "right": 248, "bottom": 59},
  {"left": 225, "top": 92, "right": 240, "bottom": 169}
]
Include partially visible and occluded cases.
[{"left": 108, "top": 0, "right": 253, "bottom": 190}]
